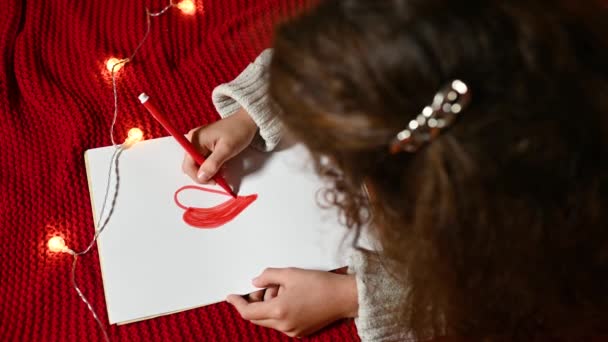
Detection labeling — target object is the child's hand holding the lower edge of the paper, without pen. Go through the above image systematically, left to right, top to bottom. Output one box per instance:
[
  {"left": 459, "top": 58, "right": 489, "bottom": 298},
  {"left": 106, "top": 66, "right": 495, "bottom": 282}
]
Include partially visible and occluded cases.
[{"left": 226, "top": 268, "right": 358, "bottom": 337}]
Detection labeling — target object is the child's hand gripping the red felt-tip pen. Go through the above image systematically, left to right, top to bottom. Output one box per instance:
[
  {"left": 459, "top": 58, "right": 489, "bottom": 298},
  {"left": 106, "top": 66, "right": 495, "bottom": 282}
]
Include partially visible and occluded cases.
[{"left": 182, "top": 108, "right": 258, "bottom": 183}]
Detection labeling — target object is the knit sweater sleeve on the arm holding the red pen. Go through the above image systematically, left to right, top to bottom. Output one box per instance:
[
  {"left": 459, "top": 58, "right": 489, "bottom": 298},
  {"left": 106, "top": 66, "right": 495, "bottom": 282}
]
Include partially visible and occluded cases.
[{"left": 211, "top": 49, "right": 282, "bottom": 151}]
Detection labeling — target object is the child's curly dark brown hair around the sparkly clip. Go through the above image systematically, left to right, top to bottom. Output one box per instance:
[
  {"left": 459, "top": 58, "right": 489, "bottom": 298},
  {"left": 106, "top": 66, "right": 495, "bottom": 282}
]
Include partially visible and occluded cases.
[{"left": 270, "top": 0, "right": 608, "bottom": 340}]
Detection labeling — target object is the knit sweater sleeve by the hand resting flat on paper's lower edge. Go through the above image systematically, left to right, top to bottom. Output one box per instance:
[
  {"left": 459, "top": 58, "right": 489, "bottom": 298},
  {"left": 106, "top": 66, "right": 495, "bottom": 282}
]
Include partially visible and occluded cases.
[{"left": 349, "top": 250, "right": 416, "bottom": 342}]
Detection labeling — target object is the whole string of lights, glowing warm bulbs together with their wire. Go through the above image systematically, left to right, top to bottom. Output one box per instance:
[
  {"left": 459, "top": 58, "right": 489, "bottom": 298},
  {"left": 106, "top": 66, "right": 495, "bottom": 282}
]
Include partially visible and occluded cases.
[{"left": 47, "top": 0, "right": 196, "bottom": 342}]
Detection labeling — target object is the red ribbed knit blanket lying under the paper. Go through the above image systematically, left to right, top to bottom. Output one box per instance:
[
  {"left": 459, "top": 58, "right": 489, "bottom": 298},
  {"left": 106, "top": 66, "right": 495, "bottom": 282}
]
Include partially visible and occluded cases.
[{"left": 0, "top": 0, "right": 358, "bottom": 341}]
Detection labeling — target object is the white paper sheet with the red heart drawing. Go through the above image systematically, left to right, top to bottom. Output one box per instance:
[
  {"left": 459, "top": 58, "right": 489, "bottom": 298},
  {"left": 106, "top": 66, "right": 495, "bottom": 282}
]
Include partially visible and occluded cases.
[{"left": 85, "top": 137, "right": 351, "bottom": 324}]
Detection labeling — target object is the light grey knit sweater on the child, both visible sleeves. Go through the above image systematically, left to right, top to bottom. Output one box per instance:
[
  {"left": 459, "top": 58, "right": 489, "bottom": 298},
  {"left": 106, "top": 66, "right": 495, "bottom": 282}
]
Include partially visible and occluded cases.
[{"left": 212, "top": 49, "right": 413, "bottom": 342}]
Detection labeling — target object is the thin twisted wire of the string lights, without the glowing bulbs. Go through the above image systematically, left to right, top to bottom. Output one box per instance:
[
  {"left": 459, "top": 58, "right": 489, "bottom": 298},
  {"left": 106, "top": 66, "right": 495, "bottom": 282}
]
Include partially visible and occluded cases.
[{"left": 63, "top": 0, "right": 190, "bottom": 342}]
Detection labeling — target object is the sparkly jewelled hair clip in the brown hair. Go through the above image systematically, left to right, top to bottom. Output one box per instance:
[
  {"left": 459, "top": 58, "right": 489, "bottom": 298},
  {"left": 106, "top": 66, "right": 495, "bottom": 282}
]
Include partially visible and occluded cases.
[{"left": 390, "top": 80, "right": 471, "bottom": 154}]
